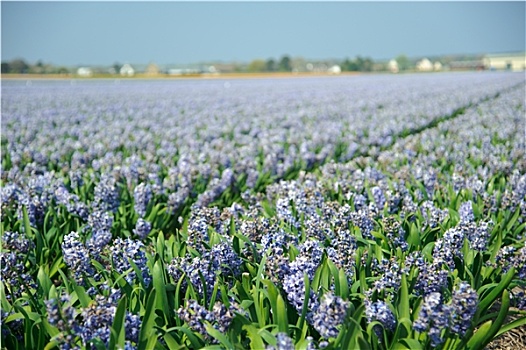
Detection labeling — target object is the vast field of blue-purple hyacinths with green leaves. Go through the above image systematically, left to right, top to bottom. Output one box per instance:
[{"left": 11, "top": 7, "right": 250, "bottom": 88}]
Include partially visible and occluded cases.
[{"left": 0, "top": 72, "right": 526, "bottom": 350}]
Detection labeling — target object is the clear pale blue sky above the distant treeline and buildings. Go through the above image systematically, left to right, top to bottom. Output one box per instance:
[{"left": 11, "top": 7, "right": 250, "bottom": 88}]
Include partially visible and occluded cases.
[{"left": 1, "top": 1, "right": 526, "bottom": 65}]
